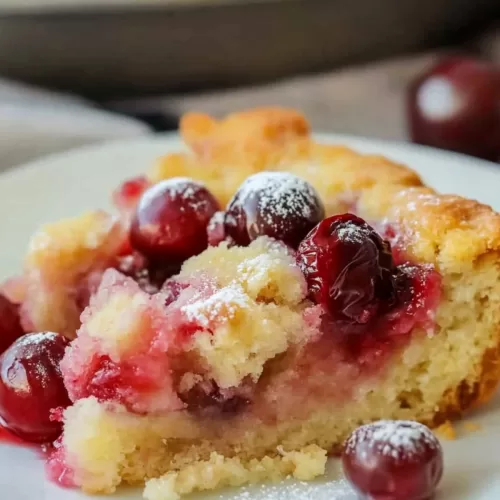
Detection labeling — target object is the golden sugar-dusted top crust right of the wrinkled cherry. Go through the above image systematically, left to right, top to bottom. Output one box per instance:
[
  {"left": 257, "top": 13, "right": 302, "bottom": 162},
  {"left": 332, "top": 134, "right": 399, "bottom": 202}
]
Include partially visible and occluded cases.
[{"left": 358, "top": 186, "right": 500, "bottom": 272}]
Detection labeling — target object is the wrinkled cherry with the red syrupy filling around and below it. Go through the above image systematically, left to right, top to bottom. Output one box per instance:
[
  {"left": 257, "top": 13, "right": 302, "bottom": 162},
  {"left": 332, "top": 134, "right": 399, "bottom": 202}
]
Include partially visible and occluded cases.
[{"left": 297, "top": 214, "right": 441, "bottom": 399}]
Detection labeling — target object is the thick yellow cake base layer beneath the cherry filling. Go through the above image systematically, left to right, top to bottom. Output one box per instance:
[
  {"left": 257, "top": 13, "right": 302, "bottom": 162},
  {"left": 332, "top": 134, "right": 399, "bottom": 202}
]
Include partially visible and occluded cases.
[{"left": 56, "top": 240, "right": 500, "bottom": 492}]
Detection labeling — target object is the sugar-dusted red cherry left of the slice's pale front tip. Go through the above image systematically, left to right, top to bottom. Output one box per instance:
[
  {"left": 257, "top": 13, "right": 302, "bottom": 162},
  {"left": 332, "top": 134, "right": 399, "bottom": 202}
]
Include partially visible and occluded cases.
[{"left": 0, "top": 332, "right": 71, "bottom": 443}]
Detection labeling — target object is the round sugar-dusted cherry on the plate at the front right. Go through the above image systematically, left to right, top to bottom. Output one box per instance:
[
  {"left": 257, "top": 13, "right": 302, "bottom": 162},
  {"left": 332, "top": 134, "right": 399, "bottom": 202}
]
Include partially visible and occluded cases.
[{"left": 342, "top": 420, "right": 443, "bottom": 500}]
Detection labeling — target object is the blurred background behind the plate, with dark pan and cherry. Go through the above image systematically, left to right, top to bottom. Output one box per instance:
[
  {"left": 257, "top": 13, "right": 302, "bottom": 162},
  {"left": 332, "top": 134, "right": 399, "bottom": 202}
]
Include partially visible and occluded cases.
[{"left": 0, "top": 0, "right": 500, "bottom": 168}]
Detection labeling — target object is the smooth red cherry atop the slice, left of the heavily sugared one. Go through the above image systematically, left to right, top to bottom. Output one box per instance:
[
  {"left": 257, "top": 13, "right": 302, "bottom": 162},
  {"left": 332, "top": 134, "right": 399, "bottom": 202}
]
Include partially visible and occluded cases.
[{"left": 130, "top": 177, "right": 219, "bottom": 262}]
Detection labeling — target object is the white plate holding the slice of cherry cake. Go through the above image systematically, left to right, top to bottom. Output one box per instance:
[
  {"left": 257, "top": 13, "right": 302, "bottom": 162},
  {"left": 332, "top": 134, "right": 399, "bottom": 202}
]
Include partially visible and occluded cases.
[{"left": 0, "top": 135, "right": 500, "bottom": 500}]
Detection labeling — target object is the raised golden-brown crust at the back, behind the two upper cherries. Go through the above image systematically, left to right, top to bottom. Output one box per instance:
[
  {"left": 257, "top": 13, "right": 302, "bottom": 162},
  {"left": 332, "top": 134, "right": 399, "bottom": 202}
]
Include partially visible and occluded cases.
[{"left": 148, "top": 108, "right": 422, "bottom": 205}]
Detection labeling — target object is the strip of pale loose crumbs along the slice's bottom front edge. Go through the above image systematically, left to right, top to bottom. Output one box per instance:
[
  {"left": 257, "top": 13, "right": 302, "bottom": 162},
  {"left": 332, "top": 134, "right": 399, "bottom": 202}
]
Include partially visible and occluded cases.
[{"left": 144, "top": 445, "right": 327, "bottom": 500}]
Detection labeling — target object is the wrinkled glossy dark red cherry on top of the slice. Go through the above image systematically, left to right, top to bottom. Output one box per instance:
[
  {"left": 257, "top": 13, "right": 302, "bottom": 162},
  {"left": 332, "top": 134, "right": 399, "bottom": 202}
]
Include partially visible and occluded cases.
[{"left": 297, "top": 214, "right": 396, "bottom": 324}]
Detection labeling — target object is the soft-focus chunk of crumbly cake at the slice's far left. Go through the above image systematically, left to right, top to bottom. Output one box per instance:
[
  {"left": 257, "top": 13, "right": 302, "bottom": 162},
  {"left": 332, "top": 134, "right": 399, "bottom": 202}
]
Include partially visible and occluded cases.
[{"left": 22, "top": 211, "right": 123, "bottom": 338}]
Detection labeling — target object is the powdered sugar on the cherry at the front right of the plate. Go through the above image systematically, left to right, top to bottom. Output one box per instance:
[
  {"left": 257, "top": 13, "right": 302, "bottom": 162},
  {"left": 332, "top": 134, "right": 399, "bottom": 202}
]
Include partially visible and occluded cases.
[{"left": 345, "top": 420, "right": 441, "bottom": 460}]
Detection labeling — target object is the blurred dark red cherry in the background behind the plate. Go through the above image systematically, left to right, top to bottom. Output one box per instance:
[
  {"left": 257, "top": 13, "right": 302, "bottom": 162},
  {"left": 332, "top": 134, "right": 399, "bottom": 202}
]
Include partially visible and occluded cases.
[{"left": 407, "top": 57, "right": 500, "bottom": 160}]
